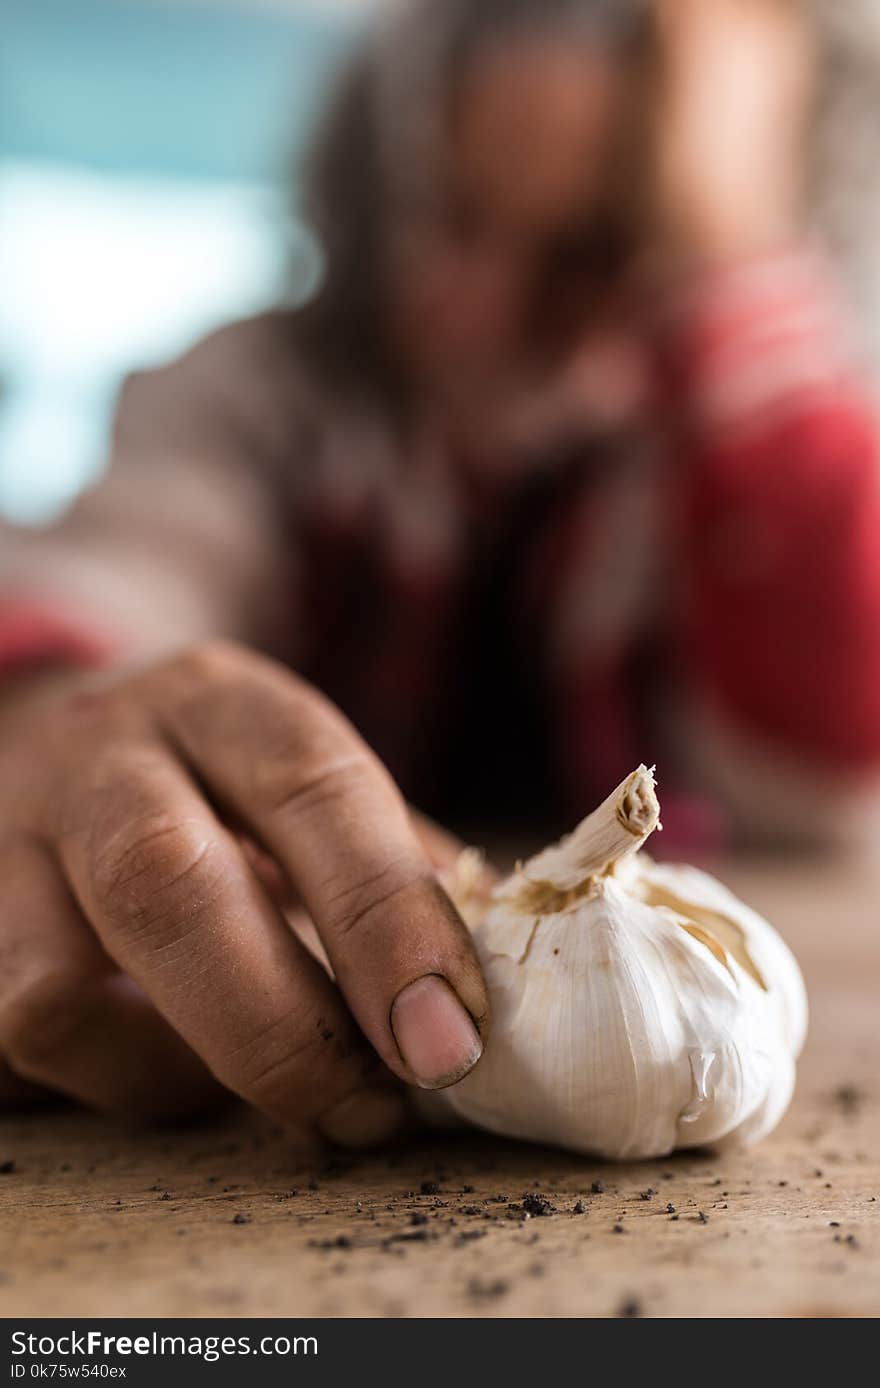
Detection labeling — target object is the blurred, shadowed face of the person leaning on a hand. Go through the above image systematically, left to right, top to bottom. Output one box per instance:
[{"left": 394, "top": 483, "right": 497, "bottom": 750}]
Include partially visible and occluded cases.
[{"left": 390, "top": 39, "right": 638, "bottom": 426}]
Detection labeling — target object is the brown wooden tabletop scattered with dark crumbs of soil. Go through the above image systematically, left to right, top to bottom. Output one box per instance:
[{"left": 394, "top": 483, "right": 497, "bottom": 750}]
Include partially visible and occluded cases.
[{"left": 0, "top": 865, "right": 880, "bottom": 1317}]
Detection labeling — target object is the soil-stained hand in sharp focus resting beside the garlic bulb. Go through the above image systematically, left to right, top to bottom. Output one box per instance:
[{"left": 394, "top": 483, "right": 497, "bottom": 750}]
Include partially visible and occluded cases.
[{"left": 0, "top": 643, "right": 489, "bottom": 1145}]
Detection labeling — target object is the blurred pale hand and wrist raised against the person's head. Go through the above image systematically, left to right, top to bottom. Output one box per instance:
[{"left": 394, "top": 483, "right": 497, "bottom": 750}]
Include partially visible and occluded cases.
[{"left": 648, "top": 0, "right": 816, "bottom": 266}]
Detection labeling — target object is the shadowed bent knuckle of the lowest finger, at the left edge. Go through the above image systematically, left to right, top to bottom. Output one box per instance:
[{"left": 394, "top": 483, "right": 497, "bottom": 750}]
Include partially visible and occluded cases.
[{"left": 0, "top": 967, "right": 97, "bottom": 1077}]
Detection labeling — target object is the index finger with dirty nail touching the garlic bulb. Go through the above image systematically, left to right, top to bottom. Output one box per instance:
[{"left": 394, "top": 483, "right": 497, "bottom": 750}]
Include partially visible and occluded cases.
[{"left": 147, "top": 643, "right": 489, "bottom": 1088}]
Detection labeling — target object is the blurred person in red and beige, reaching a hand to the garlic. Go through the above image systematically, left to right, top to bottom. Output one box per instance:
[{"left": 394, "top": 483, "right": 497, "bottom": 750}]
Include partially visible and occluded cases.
[{"left": 0, "top": 0, "right": 880, "bottom": 1127}]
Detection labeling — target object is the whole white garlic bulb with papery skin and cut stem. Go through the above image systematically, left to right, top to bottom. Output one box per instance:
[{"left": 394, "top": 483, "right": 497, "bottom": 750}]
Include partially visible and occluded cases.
[{"left": 421, "top": 766, "right": 806, "bottom": 1158}]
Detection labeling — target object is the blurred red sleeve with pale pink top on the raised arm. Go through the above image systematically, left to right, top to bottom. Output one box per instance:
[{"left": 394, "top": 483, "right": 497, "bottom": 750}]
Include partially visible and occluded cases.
[{"left": 666, "top": 254, "right": 880, "bottom": 769}]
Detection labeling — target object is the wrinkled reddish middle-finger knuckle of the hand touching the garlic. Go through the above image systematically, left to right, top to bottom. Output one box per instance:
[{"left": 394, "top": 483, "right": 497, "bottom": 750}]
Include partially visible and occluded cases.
[{"left": 90, "top": 812, "right": 228, "bottom": 933}]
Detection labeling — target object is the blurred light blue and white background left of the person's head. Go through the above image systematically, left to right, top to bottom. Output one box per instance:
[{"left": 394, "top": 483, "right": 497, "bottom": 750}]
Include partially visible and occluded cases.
[{"left": 0, "top": 0, "right": 368, "bottom": 521}]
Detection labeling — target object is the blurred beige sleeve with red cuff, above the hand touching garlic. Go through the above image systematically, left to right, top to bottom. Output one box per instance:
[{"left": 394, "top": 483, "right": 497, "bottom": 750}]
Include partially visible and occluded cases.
[{"left": 0, "top": 315, "right": 301, "bottom": 677}]
